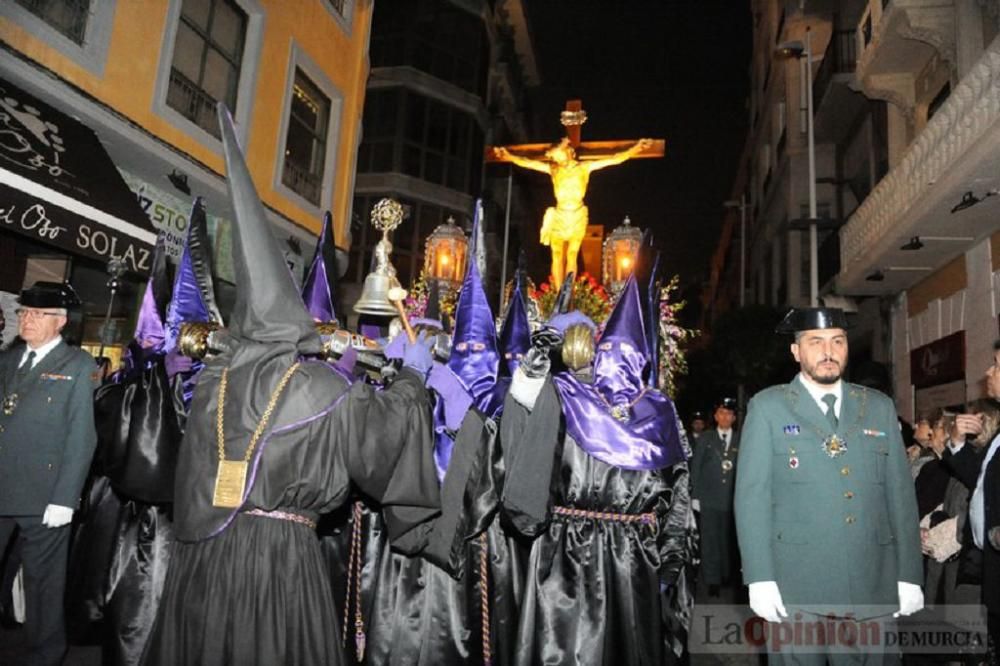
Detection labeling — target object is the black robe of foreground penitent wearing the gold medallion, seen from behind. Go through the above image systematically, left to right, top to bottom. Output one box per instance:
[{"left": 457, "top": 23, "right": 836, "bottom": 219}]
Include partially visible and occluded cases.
[{"left": 143, "top": 343, "right": 440, "bottom": 666}]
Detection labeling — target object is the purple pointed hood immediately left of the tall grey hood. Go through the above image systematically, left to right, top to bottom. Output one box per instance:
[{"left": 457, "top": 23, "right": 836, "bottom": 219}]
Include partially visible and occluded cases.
[{"left": 164, "top": 197, "right": 221, "bottom": 351}]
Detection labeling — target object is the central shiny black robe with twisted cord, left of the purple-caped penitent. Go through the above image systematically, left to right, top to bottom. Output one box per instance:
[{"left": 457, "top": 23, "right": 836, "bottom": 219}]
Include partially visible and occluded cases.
[{"left": 366, "top": 410, "right": 524, "bottom": 666}]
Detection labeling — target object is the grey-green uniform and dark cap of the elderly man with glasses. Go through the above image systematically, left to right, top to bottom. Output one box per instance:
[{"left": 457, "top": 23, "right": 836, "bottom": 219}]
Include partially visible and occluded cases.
[{"left": 0, "top": 282, "right": 97, "bottom": 664}]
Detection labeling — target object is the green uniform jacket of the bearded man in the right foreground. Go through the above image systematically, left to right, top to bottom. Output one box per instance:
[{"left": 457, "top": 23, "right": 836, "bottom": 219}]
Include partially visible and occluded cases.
[{"left": 735, "top": 377, "right": 923, "bottom": 618}]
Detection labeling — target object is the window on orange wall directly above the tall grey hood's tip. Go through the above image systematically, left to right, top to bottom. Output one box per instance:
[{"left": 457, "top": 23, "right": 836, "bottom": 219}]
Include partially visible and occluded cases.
[{"left": 167, "top": 0, "right": 247, "bottom": 137}]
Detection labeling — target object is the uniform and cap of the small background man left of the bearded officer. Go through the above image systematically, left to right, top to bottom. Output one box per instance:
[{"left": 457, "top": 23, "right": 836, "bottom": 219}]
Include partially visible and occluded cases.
[{"left": 691, "top": 398, "right": 739, "bottom": 594}]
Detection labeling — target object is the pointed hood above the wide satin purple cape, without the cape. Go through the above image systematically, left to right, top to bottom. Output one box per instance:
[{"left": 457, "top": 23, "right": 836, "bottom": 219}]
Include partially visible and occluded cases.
[{"left": 594, "top": 274, "right": 650, "bottom": 405}]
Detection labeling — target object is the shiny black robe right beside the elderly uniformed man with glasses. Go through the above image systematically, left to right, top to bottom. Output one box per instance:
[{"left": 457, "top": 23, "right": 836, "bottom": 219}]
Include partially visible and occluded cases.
[{"left": 67, "top": 344, "right": 185, "bottom": 666}]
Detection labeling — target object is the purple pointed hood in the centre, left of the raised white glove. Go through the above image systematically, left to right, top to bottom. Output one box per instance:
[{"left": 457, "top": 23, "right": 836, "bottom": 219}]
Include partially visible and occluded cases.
[{"left": 448, "top": 200, "right": 500, "bottom": 416}]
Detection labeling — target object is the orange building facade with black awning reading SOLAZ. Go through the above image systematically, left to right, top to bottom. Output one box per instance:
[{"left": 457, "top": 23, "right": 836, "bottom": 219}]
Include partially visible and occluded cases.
[{"left": 0, "top": 0, "right": 372, "bottom": 358}]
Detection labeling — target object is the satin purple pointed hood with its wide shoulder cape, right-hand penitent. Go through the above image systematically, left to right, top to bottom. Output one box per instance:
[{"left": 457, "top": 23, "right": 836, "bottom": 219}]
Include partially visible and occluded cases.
[{"left": 553, "top": 275, "right": 686, "bottom": 470}]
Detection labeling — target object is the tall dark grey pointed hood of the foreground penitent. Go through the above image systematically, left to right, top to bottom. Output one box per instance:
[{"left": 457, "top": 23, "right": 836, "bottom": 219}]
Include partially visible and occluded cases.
[{"left": 218, "top": 103, "right": 320, "bottom": 353}]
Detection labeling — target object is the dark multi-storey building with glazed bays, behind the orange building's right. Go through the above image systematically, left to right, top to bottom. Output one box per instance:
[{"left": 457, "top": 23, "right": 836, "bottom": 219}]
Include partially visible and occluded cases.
[{"left": 342, "top": 0, "right": 539, "bottom": 314}]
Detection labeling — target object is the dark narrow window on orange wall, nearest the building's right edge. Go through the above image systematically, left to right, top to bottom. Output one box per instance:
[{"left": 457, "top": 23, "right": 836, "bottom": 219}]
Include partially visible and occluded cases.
[{"left": 281, "top": 70, "right": 330, "bottom": 206}]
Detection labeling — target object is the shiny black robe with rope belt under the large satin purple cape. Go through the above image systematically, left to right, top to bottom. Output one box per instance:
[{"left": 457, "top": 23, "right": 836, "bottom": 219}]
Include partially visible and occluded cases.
[{"left": 501, "top": 381, "right": 695, "bottom": 666}]
